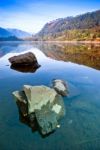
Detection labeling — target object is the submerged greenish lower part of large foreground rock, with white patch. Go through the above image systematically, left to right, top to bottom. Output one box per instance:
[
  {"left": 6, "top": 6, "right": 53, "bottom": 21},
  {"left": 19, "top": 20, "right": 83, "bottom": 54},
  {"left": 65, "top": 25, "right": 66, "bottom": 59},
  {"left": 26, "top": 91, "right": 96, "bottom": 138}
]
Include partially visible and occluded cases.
[{"left": 35, "top": 95, "right": 65, "bottom": 134}]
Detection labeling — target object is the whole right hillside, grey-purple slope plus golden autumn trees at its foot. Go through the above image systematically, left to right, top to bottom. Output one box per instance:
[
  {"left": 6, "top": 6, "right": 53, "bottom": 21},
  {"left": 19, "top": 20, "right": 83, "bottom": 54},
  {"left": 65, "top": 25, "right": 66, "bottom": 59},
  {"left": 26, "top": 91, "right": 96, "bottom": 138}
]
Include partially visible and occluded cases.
[{"left": 36, "top": 10, "right": 100, "bottom": 40}]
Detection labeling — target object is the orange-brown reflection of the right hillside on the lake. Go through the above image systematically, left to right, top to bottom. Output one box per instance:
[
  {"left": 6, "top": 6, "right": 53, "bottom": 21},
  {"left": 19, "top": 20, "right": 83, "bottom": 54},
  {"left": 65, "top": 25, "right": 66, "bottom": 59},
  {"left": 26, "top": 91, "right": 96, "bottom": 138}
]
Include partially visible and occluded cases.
[{"left": 33, "top": 44, "right": 100, "bottom": 69}]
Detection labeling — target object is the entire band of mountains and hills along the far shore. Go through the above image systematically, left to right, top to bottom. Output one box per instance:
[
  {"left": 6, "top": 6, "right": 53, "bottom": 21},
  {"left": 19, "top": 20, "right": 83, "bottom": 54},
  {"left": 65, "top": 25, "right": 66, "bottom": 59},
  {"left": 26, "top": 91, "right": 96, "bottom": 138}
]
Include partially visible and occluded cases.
[{"left": 0, "top": 10, "right": 100, "bottom": 41}]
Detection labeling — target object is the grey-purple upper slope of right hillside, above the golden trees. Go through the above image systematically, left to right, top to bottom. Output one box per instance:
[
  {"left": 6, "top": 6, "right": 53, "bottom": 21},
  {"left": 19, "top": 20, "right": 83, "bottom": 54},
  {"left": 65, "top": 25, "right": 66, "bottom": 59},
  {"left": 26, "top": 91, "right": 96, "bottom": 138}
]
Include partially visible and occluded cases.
[{"left": 37, "top": 10, "right": 100, "bottom": 38}]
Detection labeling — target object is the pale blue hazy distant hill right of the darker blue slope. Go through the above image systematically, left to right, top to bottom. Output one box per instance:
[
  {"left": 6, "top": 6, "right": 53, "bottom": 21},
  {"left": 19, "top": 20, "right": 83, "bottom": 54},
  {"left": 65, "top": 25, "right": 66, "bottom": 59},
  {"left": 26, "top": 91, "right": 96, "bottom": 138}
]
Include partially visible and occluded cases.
[{"left": 7, "top": 28, "right": 32, "bottom": 39}]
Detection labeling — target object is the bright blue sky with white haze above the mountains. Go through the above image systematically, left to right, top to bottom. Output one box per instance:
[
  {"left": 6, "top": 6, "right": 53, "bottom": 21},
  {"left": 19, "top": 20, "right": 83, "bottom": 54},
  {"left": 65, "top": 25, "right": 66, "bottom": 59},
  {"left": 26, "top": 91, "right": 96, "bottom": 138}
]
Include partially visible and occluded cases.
[{"left": 0, "top": 0, "right": 100, "bottom": 33}]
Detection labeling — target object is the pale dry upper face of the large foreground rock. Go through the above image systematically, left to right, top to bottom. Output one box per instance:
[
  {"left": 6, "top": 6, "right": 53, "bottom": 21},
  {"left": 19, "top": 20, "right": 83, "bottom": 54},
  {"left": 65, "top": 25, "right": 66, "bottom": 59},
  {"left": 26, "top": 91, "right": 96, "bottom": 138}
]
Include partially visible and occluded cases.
[{"left": 24, "top": 85, "right": 57, "bottom": 114}]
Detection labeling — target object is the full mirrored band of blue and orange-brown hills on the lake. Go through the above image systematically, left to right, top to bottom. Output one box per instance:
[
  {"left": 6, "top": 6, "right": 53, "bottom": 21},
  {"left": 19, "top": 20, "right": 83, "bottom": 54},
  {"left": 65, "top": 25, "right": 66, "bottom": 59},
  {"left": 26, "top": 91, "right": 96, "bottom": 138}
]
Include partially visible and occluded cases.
[{"left": 0, "top": 42, "right": 100, "bottom": 70}]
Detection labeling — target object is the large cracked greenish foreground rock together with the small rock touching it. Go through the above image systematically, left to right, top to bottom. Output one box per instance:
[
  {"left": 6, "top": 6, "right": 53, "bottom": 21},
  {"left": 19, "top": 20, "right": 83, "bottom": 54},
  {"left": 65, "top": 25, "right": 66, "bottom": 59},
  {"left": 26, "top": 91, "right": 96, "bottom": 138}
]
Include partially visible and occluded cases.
[{"left": 13, "top": 80, "right": 68, "bottom": 135}]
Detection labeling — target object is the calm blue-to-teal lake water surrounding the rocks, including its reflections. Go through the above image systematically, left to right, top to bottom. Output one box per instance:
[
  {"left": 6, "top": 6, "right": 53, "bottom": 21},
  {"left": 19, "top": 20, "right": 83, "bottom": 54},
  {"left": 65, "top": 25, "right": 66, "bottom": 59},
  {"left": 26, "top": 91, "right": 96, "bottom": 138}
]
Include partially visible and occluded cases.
[{"left": 0, "top": 42, "right": 100, "bottom": 150}]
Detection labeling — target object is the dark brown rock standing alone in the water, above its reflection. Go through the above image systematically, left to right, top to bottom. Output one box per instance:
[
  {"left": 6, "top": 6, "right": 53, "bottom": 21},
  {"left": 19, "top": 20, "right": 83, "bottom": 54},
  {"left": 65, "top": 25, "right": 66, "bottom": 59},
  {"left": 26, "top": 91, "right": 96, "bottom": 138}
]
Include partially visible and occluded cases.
[{"left": 9, "top": 52, "right": 39, "bottom": 67}]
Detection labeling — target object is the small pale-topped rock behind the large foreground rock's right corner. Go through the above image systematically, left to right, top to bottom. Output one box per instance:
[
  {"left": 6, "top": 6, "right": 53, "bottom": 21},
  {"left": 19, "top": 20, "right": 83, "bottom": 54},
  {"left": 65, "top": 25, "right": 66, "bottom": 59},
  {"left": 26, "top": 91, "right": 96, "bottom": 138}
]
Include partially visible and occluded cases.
[{"left": 52, "top": 79, "right": 69, "bottom": 96}]
